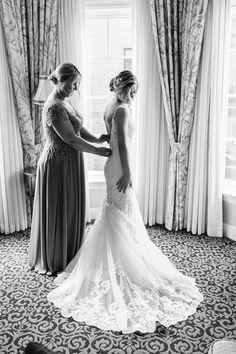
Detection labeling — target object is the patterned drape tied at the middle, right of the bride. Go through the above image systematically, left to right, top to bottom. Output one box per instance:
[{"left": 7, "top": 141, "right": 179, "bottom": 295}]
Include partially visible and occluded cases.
[{"left": 150, "top": 0, "right": 208, "bottom": 230}]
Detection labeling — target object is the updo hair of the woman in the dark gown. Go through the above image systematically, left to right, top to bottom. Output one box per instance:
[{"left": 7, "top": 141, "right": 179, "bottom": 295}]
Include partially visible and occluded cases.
[{"left": 48, "top": 63, "right": 81, "bottom": 85}]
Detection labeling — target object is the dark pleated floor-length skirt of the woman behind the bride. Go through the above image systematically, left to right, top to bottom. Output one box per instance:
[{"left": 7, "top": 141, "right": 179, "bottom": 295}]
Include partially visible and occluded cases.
[{"left": 29, "top": 149, "right": 85, "bottom": 274}]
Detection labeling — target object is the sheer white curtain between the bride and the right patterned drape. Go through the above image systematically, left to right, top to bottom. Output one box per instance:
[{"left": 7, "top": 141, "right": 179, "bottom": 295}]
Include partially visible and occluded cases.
[{"left": 133, "top": 0, "right": 169, "bottom": 225}]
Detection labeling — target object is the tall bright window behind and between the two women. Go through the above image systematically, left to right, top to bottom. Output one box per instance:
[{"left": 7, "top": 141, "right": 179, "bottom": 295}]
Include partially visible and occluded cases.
[{"left": 85, "top": 0, "right": 132, "bottom": 176}]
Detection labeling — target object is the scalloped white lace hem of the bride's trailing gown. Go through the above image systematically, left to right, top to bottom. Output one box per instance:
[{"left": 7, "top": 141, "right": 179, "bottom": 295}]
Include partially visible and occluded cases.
[{"left": 48, "top": 262, "right": 203, "bottom": 333}]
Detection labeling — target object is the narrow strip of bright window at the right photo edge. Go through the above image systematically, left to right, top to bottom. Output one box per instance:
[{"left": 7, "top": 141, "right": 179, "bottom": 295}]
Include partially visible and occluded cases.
[{"left": 225, "top": 0, "right": 236, "bottom": 185}]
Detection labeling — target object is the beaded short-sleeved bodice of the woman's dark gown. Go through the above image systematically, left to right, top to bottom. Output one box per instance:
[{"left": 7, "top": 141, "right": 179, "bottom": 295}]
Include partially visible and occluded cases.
[{"left": 42, "top": 100, "right": 83, "bottom": 158}]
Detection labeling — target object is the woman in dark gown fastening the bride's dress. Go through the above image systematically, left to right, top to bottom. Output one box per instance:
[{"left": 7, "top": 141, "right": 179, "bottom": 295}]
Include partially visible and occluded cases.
[{"left": 29, "top": 63, "right": 110, "bottom": 275}]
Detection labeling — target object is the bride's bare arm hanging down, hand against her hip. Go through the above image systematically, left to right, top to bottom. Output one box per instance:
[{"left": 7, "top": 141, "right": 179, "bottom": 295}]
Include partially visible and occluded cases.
[{"left": 114, "top": 107, "right": 131, "bottom": 192}]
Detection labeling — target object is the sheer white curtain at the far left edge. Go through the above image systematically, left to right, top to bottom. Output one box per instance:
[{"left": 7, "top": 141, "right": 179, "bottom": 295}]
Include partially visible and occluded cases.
[{"left": 0, "top": 21, "right": 27, "bottom": 234}]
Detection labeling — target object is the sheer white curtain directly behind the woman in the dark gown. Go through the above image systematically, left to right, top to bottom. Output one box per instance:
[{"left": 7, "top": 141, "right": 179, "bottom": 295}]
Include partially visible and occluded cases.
[{"left": 56, "top": 0, "right": 91, "bottom": 221}]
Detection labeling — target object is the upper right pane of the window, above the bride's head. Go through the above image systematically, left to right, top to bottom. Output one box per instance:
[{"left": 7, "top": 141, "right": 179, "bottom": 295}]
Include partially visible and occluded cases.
[{"left": 109, "top": 18, "right": 132, "bottom": 57}]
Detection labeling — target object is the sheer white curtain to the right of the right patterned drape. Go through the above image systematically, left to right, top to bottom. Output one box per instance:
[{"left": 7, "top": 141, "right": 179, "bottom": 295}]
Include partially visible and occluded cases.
[{"left": 185, "top": 0, "right": 228, "bottom": 237}]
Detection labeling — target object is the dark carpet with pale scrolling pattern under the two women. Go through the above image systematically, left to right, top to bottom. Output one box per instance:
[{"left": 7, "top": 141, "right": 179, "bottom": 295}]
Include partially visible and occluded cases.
[{"left": 0, "top": 226, "right": 236, "bottom": 354}]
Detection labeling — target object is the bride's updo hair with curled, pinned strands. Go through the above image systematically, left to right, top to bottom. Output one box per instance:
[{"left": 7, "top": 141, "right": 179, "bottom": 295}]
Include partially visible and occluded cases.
[{"left": 109, "top": 70, "right": 138, "bottom": 93}]
